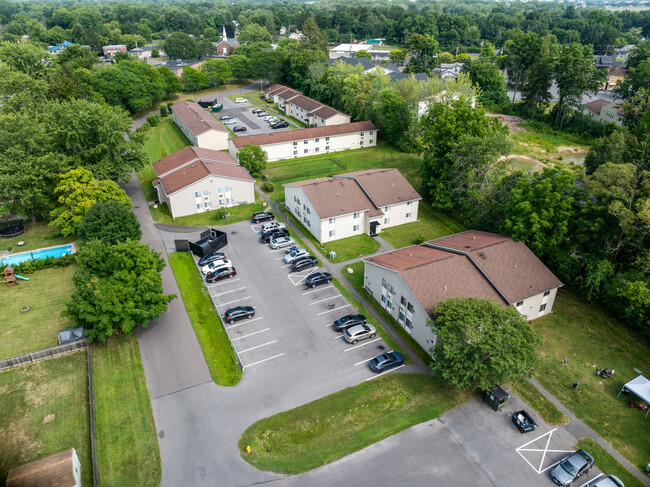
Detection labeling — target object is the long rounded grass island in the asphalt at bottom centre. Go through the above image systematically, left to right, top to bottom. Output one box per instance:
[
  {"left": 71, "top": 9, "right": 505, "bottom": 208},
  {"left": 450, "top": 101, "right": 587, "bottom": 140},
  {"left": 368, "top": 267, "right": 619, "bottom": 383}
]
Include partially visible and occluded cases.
[{"left": 239, "top": 373, "right": 472, "bottom": 474}]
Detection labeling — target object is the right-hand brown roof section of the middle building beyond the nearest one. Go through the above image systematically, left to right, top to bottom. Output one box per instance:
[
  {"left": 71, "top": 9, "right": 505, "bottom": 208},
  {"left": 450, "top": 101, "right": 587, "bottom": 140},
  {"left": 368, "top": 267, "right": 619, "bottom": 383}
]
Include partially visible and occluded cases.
[{"left": 334, "top": 168, "right": 422, "bottom": 207}]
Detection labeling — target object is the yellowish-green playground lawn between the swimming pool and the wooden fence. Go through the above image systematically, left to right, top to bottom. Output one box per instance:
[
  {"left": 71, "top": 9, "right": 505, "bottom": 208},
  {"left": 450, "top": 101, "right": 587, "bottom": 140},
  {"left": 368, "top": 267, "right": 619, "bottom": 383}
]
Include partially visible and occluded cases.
[{"left": 0, "top": 265, "right": 77, "bottom": 358}]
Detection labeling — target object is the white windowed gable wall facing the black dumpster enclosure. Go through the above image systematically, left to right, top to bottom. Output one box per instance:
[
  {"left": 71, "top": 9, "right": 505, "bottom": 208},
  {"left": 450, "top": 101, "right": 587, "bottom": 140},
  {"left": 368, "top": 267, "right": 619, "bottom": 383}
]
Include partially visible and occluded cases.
[{"left": 165, "top": 176, "right": 255, "bottom": 218}]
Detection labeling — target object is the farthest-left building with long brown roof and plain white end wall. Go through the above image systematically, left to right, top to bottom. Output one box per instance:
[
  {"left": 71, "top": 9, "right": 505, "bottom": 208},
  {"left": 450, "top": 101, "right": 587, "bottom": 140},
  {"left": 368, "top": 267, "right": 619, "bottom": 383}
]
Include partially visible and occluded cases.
[{"left": 172, "top": 101, "right": 229, "bottom": 150}]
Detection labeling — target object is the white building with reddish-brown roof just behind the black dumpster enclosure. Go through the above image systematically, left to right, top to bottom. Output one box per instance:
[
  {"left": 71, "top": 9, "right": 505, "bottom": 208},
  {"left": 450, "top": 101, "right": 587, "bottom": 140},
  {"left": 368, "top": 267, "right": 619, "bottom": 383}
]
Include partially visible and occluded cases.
[{"left": 153, "top": 147, "right": 255, "bottom": 218}]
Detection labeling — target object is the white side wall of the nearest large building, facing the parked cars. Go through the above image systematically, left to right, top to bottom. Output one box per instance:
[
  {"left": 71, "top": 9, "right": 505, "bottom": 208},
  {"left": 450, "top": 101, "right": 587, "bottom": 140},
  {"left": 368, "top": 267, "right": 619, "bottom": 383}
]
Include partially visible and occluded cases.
[{"left": 363, "top": 262, "right": 436, "bottom": 351}]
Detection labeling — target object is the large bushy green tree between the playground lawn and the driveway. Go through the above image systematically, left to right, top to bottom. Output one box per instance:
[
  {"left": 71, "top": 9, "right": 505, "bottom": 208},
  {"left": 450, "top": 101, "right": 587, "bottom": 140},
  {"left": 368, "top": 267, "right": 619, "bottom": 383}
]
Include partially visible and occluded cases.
[{"left": 64, "top": 240, "right": 176, "bottom": 342}]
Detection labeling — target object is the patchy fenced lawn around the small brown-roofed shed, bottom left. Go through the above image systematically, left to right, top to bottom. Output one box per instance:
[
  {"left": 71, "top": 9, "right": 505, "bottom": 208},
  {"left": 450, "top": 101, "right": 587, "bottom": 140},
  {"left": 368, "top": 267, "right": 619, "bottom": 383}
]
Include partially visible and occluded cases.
[{"left": 0, "top": 350, "right": 91, "bottom": 487}]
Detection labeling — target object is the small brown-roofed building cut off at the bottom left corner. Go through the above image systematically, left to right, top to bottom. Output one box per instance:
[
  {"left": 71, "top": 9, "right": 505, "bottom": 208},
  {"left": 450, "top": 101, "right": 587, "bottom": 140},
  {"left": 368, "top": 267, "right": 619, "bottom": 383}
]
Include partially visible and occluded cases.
[{"left": 5, "top": 448, "right": 81, "bottom": 487}]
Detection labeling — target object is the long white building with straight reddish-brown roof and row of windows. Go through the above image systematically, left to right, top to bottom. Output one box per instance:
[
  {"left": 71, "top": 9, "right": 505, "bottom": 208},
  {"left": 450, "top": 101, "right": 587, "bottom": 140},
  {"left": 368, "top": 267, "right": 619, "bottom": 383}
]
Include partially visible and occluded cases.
[{"left": 228, "top": 121, "right": 377, "bottom": 161}]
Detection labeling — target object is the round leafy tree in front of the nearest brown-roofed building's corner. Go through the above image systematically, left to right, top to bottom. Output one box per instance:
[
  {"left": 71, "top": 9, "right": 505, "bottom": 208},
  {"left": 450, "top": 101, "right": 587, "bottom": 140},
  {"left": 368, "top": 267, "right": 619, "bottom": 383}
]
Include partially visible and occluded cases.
[{"left": 429, "top": 298, "right": 540, "bottom": 391}]
